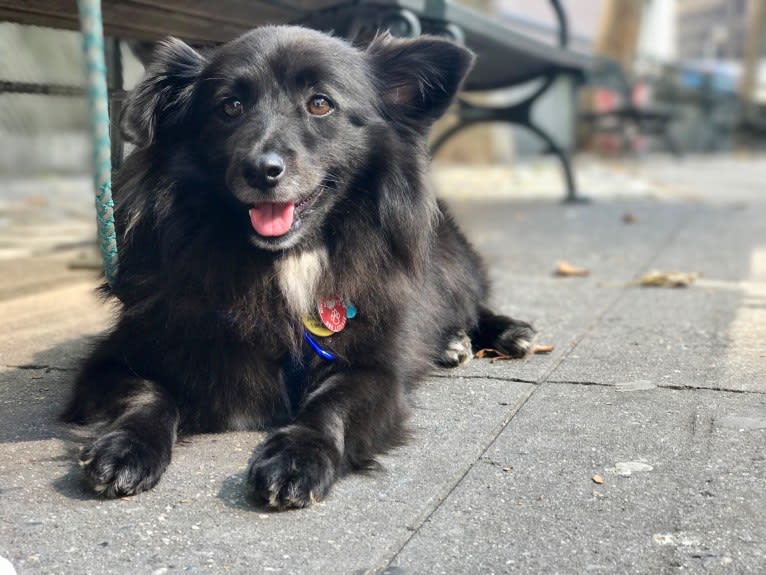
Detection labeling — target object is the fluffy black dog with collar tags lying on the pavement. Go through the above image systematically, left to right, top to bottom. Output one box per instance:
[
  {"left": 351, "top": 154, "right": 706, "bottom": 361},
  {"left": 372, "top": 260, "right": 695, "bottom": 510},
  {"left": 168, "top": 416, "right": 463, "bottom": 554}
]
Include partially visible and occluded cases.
[{"left": 64, "top": 27, "right": 534, "bottom": 509}]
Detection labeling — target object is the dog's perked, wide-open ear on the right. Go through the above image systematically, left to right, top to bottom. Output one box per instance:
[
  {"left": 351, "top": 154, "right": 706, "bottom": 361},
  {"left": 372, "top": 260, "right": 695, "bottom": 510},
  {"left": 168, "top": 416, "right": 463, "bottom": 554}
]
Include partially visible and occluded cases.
[{"left": 367, "top": 33, "right": 474, "bottom": 132}]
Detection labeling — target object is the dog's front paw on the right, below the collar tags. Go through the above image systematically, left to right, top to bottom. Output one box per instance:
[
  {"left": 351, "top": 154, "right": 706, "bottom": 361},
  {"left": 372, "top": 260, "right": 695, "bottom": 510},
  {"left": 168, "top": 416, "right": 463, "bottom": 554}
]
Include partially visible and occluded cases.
[{"left": 247, "top": 425, "right": 340, "bottom": 510}]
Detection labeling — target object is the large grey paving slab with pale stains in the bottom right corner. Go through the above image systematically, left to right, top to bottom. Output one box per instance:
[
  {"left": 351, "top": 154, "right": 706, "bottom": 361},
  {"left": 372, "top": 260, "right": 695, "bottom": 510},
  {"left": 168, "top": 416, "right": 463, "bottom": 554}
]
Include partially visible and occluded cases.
[{"left": 390, "top": 383, "right": 766, "bottom": 575}]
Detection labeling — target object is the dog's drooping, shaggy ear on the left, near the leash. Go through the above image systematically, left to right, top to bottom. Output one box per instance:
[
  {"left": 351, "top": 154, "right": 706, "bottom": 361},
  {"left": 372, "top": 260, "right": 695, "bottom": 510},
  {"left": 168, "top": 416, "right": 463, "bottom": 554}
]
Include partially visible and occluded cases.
[{"left": 120, "top": 38, "right": 205, "bottom": 148}]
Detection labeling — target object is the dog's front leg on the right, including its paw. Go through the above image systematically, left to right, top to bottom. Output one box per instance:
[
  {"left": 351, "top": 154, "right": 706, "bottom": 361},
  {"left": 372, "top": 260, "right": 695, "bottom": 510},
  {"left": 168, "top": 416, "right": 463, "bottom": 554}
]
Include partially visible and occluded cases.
[{"left": 248, "top": 368, "right": 406, "bottom": 509}]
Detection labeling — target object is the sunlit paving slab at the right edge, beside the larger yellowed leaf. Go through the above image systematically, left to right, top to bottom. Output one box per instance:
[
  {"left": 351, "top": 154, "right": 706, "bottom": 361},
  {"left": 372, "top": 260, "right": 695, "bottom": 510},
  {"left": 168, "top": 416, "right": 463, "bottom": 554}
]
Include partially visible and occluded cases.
[{"left": 552, "top": 203, "right": 766, "bottom": 393}]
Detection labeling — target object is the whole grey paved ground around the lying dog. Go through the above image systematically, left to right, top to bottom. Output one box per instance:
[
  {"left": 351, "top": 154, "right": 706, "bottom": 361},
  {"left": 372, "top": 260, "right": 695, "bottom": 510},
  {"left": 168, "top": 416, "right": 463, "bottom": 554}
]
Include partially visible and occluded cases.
[{"left": 0, "top": 158, "right": 766, "bottom": 575}]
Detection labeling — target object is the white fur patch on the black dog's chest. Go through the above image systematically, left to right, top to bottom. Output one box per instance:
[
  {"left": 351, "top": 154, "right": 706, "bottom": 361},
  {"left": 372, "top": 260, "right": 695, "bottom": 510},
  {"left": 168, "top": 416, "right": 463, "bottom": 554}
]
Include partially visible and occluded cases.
[{"left": 277, "top": 249, "right": 327, "bottom": 315}]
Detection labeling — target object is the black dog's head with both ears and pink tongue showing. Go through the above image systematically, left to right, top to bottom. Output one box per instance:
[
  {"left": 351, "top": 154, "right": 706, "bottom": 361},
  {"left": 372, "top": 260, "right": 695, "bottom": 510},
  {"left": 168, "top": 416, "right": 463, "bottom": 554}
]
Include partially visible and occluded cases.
[{"left": 122, "top": 26, "right": 472, "bottom": 251}]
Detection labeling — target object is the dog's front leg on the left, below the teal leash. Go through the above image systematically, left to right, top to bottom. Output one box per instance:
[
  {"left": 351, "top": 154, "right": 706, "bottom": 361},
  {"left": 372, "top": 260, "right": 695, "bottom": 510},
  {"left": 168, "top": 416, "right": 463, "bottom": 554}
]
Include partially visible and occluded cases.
[{"left": 62, "top": 361, "right": 179, "bottom": 497}]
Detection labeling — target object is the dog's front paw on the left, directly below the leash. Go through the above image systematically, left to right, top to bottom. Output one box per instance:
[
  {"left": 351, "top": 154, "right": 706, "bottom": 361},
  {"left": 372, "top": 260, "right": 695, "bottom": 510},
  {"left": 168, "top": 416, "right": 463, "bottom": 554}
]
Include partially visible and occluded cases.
[{"left": 80, "top": 429, "right": 170, "bottom": 497}]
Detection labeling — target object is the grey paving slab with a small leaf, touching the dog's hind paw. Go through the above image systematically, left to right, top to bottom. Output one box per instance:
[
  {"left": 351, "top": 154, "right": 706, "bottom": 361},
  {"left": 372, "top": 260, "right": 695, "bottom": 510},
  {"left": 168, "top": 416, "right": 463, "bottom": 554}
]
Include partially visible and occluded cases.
[{"left": 451, "top": 200, "right": 700, "bottom": 388}]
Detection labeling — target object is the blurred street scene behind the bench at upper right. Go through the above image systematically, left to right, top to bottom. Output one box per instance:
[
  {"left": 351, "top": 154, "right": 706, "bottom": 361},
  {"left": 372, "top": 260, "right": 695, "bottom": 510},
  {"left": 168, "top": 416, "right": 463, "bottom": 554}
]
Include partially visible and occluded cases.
[{"left": 438, "top": 0, "right": 766, "bottom": 162}]
